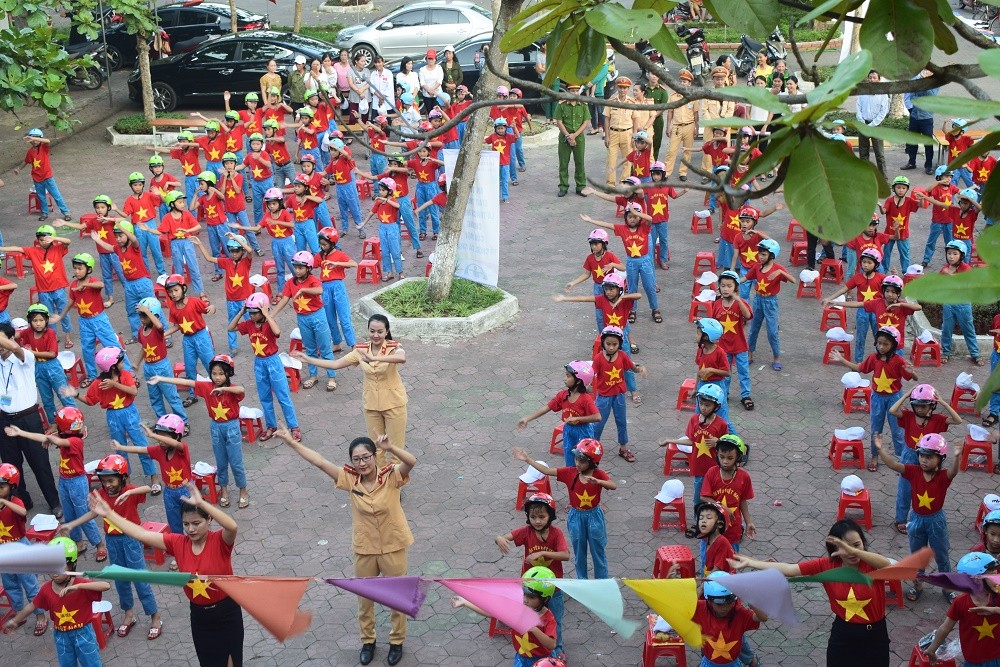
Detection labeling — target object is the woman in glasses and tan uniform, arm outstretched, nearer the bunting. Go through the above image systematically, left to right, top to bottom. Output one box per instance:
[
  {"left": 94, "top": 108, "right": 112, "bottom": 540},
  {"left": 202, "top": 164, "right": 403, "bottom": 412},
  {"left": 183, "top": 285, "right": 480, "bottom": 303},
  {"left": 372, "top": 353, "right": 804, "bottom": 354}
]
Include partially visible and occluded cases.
[{"left": 277, "top": 429, "right": 417, "bottom": 665}]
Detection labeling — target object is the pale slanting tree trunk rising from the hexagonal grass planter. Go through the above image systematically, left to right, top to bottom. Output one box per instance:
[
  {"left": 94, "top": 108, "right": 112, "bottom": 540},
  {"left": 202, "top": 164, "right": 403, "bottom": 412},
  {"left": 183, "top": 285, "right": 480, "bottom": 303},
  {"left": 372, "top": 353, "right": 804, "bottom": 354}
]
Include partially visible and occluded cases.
[{"left": 426, "top": 0, "right": 523, "bottom": 302}]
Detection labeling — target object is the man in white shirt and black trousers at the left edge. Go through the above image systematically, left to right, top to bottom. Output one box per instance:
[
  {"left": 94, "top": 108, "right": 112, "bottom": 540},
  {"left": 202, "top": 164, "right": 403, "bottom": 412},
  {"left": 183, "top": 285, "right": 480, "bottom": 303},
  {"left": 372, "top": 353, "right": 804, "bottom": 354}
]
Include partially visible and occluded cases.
[{"left": 0, "top": 322, "right": 62, "bottom": 520}]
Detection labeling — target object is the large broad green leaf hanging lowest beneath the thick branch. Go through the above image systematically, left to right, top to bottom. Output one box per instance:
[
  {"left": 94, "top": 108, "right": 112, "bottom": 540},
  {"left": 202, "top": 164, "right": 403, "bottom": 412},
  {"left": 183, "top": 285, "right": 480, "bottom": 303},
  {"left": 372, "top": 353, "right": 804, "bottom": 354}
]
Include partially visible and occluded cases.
[{"left": 785, "top": 133, "right": 878, "bottom": 243}]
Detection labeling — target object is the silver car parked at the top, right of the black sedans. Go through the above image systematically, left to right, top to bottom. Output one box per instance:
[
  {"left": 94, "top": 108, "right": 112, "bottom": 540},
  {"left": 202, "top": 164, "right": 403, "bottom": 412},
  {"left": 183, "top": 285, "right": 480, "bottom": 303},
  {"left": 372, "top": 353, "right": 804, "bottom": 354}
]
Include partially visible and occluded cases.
[{"left": 334, "top": 0, "right": 493, "bottom": 63}]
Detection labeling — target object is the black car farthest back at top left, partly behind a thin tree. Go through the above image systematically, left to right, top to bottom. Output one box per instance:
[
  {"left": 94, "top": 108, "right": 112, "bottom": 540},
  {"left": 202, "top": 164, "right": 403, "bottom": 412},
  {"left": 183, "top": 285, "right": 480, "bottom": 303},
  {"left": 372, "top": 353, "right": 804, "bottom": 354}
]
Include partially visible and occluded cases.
[{"left": 69, "top": 0, "right": 271, "bottom": 69}]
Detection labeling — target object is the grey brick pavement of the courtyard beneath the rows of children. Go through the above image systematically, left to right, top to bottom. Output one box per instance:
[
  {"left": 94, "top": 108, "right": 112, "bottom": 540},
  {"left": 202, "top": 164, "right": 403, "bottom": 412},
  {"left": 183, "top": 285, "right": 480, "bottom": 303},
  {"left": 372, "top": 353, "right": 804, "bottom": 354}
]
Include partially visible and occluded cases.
[{"left": 0, "top": 116, "right": 996, "bottom": 667}]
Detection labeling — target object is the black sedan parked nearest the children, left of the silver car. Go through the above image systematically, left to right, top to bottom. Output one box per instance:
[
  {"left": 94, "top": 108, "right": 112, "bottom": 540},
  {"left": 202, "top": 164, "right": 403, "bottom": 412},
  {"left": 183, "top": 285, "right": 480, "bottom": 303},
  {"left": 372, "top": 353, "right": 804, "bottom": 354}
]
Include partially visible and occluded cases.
[{"left": 128, "top": 30, "right": 333, "bottom": 111}]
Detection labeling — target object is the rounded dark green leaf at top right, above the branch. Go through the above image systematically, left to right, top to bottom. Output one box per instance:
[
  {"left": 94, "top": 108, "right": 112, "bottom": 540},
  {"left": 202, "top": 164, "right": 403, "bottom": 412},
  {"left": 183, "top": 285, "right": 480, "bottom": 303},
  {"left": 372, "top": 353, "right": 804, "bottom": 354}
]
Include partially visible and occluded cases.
[{"left": 858, "top": 0, "right": 934, "bottom": 79}]
